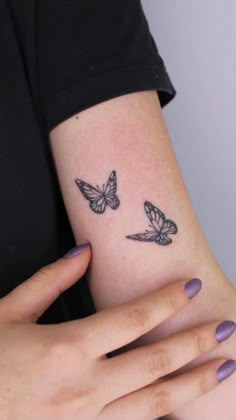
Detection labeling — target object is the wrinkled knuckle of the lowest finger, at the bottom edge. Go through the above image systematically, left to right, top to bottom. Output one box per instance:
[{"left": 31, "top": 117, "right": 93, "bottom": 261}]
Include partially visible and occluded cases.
[{"left": 149, "top": 390, "right": 173, "bottom": 417}]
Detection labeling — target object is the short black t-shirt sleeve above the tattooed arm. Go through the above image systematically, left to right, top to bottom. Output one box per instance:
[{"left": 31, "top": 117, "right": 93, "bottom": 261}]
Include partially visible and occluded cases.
[{"left": 37, "top": 0, "right": 176, "bottom": 132}]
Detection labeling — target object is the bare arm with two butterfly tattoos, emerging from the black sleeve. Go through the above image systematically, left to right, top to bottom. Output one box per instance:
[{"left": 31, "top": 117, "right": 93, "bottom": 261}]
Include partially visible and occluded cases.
[{"left": 50, "top": 91, "right": 236, "bottom": 420}]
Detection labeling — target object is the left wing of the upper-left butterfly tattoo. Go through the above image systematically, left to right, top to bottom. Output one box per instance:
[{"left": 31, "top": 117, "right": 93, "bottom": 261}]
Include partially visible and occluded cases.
[{"left": 75, "top": 179, "right": 106, "bottom": 213}]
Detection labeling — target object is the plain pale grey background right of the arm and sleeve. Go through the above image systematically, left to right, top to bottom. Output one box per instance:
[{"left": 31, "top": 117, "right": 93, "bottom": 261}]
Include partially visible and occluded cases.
[{"left": 142, "top": 0, "right": 236, "bottom": 284}]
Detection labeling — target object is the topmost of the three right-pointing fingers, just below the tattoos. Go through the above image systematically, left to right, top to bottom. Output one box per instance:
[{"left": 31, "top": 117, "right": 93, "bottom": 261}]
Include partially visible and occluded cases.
[{"left": 71, "top": 279, "right": 202, "bottom": 357}]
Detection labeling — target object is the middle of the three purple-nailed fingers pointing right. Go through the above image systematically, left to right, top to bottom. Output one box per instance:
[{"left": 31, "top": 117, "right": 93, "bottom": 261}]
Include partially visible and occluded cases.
[{"left": 100, "top": 321, "right": 236, "bottom": 403}]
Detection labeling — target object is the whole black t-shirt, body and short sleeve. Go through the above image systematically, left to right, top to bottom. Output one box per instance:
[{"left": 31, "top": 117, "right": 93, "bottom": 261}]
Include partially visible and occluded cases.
[{"left": 0, "top": 0, "right": 176, "bottom": 323}]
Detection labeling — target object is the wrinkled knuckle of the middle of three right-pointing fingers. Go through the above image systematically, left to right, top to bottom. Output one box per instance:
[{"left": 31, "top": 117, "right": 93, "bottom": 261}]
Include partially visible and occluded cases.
[{"left": 147, "top": 349, "right": 171, "bottom": 379}]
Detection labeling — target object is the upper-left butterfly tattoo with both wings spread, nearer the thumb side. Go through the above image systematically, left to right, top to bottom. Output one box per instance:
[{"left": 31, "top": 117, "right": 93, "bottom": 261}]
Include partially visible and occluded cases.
[{"left": 75, "top": 171, "right": 120, "bottom": 214}]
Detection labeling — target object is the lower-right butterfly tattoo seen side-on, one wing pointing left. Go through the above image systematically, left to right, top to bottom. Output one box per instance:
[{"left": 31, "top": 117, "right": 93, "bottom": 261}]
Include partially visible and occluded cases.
[{"left": 126, "top": 201, "right": 178, "bottom": 245}]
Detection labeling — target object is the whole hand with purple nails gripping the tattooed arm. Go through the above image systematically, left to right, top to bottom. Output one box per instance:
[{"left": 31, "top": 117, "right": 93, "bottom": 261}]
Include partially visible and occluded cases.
[{"left": 0, "top": 246, "right": 236, "bottom": 420}]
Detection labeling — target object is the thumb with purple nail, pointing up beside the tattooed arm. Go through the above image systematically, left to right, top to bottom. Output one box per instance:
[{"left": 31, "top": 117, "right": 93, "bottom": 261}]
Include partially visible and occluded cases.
[{"left": 0, "top": 243, "right": 91, "bottom": 322}]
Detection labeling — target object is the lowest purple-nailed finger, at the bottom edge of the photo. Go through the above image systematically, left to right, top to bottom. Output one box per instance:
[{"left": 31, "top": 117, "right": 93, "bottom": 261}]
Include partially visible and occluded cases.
[{"left": 101, "top": 359, "right": 236, "bottom": 420}]
